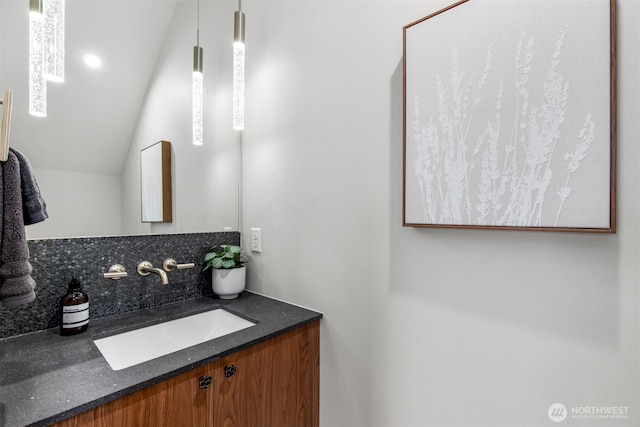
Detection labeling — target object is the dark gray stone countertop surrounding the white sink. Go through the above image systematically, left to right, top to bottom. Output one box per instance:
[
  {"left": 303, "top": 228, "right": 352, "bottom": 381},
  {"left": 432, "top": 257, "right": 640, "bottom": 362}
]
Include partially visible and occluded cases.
[{"left": 0, "top": 291, "right": 322, "bottom": 427}]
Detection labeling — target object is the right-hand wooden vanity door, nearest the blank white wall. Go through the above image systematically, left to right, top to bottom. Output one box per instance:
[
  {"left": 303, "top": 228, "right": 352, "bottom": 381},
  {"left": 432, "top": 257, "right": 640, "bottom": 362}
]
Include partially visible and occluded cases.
[{"left": 214, "top": 322, "right": 320, "bottom": 427}]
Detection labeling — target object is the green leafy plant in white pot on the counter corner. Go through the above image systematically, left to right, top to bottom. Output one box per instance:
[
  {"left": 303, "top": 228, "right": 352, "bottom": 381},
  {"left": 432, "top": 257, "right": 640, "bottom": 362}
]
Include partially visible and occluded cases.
[{"left": 202, "top": 245, "right": 247, "bottom": 299}]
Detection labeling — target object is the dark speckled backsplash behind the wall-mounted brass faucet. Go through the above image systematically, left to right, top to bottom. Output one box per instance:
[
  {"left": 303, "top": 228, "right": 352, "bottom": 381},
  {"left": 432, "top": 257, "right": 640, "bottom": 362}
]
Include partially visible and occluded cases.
[{"left": 0, "top": 231, "right": 240, "bottom": 338}]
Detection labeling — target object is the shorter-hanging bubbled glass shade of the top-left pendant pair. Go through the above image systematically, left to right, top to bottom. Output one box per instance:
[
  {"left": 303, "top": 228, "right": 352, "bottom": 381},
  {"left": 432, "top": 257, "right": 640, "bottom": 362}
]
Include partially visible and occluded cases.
[{"left": 44, "top": 0, "right": 65, "bottom": 82}]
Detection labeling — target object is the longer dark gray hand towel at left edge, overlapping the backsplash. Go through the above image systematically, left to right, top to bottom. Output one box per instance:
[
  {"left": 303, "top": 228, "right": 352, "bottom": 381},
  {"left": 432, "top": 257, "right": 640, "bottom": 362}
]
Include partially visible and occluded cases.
[{"left": 0, "top": 152, "right": 36, "bottom": 307}]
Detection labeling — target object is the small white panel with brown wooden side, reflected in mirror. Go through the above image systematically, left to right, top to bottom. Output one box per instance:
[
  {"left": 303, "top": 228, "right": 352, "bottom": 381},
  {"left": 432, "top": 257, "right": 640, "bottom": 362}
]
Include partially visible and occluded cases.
[{"left": 140, "top": 141, "right": 172, "bottom": 222}]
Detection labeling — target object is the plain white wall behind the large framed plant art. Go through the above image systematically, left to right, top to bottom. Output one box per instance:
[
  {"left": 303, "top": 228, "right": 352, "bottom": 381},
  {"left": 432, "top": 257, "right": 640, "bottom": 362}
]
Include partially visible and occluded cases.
[{"left": 238, "top": 0, "right": 640, "bottom": 427}]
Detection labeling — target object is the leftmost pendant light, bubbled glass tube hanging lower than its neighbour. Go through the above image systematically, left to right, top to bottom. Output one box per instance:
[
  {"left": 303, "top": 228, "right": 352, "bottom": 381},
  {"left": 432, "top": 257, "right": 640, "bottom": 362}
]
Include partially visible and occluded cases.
[{"left": 29, "top": 0, "right": 47, "bottom": 117}]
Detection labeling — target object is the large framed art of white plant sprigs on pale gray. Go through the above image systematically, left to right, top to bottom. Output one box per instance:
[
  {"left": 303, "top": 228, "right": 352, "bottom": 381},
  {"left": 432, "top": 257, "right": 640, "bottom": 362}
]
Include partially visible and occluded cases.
[{"left": 403, "top": 0, "right": 616, "bottom": 233}]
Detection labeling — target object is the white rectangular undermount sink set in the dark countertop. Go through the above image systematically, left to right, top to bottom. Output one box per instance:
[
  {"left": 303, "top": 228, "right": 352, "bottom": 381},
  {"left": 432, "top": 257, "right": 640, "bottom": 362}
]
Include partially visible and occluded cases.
[{"left": 94, "top": 308, "right": 255, "bottom": 371}]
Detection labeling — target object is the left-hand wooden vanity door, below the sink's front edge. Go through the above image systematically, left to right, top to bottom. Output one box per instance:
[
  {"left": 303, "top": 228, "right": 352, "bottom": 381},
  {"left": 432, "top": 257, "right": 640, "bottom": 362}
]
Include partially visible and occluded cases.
[{"left": 55, "top": 365, "right": 213, "bottom": 427}]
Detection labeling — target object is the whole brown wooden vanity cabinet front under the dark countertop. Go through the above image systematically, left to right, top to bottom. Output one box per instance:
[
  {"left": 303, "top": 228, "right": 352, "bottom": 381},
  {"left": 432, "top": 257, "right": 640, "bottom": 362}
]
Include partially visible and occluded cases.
[{"left": 54, "top": 321, "right": 320, "bottom": 427}]
